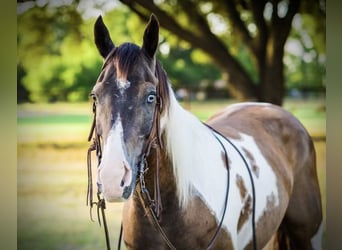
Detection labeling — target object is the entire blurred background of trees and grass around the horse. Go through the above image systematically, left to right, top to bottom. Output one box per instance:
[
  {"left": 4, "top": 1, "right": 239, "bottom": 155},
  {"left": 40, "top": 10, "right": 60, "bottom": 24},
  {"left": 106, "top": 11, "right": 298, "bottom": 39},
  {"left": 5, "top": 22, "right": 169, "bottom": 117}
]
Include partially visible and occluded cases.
[{"left": 17, "top": 0, "right": 326, "bottom": 249}]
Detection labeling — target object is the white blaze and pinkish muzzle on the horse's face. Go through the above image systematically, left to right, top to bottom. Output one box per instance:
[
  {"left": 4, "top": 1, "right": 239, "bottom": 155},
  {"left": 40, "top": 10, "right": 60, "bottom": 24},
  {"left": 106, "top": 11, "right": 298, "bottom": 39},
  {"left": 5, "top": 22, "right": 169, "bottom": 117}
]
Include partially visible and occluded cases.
[{"left": 97, "top": 116, "right": 136, "bottom": 202}]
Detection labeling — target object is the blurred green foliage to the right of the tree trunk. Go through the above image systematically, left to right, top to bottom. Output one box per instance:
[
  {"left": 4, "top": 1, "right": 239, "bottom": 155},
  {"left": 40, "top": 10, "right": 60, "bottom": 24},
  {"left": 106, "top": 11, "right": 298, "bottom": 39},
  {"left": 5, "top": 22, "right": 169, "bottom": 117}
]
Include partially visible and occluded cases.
[{"left": 284, "top": 14, "right": 326, "bottom": 92}]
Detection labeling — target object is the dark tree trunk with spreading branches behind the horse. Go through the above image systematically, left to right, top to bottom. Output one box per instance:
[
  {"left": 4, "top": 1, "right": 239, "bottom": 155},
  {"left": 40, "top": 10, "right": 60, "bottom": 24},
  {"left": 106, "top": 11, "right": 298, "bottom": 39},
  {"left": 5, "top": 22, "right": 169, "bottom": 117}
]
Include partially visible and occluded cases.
[{"left": 120, "top": 0, "right": 325, "bottom": 105}]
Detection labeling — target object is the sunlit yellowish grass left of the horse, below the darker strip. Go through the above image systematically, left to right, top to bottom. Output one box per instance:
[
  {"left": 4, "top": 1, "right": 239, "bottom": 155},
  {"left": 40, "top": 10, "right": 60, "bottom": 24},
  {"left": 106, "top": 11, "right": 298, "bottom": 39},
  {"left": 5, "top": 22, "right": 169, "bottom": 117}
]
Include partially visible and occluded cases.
[{"left": 18, "top": 144, "right": 122, "bottom": 250}]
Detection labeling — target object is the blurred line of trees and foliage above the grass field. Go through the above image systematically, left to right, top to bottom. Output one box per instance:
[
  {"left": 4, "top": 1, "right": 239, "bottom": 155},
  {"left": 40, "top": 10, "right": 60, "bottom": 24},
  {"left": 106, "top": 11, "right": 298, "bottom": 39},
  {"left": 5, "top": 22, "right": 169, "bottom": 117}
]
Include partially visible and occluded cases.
[{"left": 17, "top": 0, "right": 325, "bottom": 105}]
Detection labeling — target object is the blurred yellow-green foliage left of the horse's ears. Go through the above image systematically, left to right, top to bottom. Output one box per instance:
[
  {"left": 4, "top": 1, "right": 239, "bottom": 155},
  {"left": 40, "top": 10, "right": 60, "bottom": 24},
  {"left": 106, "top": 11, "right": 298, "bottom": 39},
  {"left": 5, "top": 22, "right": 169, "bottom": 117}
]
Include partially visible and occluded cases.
[{"left": 18, "top": 3, "right": 102, "bottom": 102}]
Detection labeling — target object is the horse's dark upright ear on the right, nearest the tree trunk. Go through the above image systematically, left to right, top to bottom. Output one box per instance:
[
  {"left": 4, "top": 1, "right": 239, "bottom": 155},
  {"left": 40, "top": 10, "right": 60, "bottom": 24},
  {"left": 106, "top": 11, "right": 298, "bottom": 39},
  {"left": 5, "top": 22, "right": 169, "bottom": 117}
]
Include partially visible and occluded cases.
[{"left": 142, "top": 14, "right": 159, "bottom": 58}]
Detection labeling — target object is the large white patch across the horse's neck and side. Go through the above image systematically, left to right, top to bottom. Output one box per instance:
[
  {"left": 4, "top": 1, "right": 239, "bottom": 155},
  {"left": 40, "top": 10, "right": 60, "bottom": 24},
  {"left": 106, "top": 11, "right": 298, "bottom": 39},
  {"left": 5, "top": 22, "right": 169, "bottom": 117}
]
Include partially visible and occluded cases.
[{"left": 162, "top": 91, "right": 279, "bottom": 249}]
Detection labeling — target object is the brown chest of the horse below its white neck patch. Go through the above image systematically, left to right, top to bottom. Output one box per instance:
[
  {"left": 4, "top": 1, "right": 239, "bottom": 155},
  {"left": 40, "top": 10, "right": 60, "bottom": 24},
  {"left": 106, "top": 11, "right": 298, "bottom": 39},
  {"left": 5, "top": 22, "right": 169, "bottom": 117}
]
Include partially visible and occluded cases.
[{"left": 123, "top": 197, "right": 233, "bottom": 249}]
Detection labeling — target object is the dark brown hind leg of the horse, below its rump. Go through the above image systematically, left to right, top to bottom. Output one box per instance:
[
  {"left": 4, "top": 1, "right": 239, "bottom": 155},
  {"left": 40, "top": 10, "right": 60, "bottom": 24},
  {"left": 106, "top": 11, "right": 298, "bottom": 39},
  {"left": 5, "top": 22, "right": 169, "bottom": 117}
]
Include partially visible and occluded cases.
[{"left": 282, "top": 144, "right": 322, "bottom": 250}]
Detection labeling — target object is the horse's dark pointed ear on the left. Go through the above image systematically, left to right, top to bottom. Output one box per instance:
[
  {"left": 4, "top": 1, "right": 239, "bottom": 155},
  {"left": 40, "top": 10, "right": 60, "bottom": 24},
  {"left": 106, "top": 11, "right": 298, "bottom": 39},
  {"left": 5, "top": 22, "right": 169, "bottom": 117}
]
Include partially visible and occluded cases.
[{"left": 94, "top": 16, "right": 115, "bottom": 58}]
